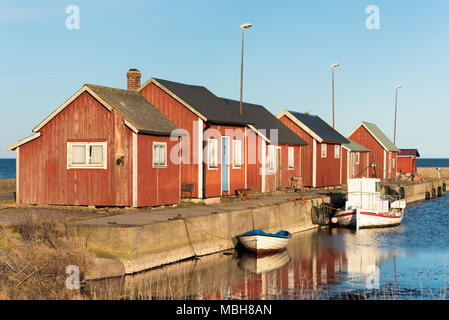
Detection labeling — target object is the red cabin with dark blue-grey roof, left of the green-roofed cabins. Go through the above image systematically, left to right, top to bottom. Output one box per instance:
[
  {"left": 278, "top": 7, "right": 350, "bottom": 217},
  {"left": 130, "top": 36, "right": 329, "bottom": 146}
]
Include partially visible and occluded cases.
[{"left": 277, "top": 110, "right": 349, "bottom": 187}]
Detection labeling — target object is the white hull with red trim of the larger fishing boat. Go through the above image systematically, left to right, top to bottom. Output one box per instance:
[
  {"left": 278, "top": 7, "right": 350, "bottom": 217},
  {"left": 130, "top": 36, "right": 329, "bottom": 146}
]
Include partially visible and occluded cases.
[{"left": 336, "top": 210, "right": 404, "bottom": 228}]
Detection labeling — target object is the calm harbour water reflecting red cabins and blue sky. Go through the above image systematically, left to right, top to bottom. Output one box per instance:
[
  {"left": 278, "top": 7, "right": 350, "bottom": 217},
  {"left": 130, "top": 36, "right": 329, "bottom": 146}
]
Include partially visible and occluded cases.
[{"left": 87, "top": 195, "right": 449, "bottom": 300}]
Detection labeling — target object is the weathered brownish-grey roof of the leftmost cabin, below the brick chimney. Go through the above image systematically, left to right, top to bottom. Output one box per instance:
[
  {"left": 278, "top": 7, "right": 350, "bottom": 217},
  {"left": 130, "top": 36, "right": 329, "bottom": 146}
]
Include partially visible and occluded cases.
[{"left": 86, "top": 84, "right": 178, "bottom": 135}]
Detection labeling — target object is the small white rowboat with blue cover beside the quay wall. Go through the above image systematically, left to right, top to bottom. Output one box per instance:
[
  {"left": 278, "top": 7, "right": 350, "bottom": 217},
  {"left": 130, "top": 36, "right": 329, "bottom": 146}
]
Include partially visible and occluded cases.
[{"left": 237, "top": 230, "right": 292, "bottom": 253}]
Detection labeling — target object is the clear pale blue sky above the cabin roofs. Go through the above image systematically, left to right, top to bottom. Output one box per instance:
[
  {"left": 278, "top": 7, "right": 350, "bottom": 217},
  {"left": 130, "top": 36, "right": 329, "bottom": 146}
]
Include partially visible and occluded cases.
[{"left": 0, "top": 0, "right": 449, "bottom": 158}]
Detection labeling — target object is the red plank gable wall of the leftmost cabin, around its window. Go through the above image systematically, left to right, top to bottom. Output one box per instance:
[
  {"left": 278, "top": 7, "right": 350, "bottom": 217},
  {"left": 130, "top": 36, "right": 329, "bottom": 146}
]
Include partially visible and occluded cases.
[{"left": 18, "top": 92, "right": 132, "bottom": 206}]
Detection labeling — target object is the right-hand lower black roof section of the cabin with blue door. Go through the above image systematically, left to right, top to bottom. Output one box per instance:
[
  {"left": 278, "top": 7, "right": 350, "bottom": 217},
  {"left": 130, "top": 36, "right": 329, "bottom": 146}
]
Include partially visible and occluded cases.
[{"left": 220, "top": 98, "right": 308, "bottom": 146}]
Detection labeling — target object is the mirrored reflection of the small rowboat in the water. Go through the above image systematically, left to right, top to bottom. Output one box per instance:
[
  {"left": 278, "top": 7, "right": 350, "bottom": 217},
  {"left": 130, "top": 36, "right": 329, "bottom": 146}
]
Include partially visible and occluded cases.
[{"left": 237, "top": 250, "right": 291, "bottom": 274}]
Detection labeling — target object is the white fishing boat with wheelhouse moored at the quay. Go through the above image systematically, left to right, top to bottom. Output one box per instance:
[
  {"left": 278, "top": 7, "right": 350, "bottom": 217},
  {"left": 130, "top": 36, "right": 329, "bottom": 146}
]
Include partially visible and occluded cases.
[{"left": 332, "top": 178, "right": 406, "bottom": 229}]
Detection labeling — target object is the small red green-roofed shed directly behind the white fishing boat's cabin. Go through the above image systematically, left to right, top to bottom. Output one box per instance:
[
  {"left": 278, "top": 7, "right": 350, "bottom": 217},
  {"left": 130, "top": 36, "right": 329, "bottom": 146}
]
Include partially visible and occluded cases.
[{"left": 342, "top": 139, "right": 370, "bottom": 184}]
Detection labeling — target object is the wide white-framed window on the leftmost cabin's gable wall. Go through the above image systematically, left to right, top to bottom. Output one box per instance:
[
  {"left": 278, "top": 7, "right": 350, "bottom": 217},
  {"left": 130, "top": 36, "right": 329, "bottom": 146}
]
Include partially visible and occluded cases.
[{"left": 67, "top": 142, "right": 107, "bottom": 169}]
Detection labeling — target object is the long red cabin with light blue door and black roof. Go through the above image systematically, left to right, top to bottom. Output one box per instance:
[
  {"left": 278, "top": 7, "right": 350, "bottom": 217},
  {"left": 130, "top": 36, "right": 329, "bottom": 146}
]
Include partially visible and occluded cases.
[{"left": 139, "top": 78, "right": 305, "bottom": 198}]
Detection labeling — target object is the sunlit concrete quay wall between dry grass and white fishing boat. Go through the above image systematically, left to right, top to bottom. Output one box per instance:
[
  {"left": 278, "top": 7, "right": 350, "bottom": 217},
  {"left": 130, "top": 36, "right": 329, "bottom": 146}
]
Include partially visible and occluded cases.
[{"left": 72, "top": 195, "right": 330, "bottom": 280}]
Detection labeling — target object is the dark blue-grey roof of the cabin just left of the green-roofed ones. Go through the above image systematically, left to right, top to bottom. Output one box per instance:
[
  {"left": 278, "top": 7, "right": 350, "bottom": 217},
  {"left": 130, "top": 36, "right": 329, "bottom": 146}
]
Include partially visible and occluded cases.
[{"left": 288, "top": 111, "right": 349, "bottom": 143}]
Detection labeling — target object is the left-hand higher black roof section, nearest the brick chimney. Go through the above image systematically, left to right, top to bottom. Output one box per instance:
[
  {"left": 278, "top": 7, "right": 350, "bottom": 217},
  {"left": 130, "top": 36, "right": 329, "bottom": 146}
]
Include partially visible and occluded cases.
[{"left": 153, "top": 78, "right": 252, "bottom": 125}]
